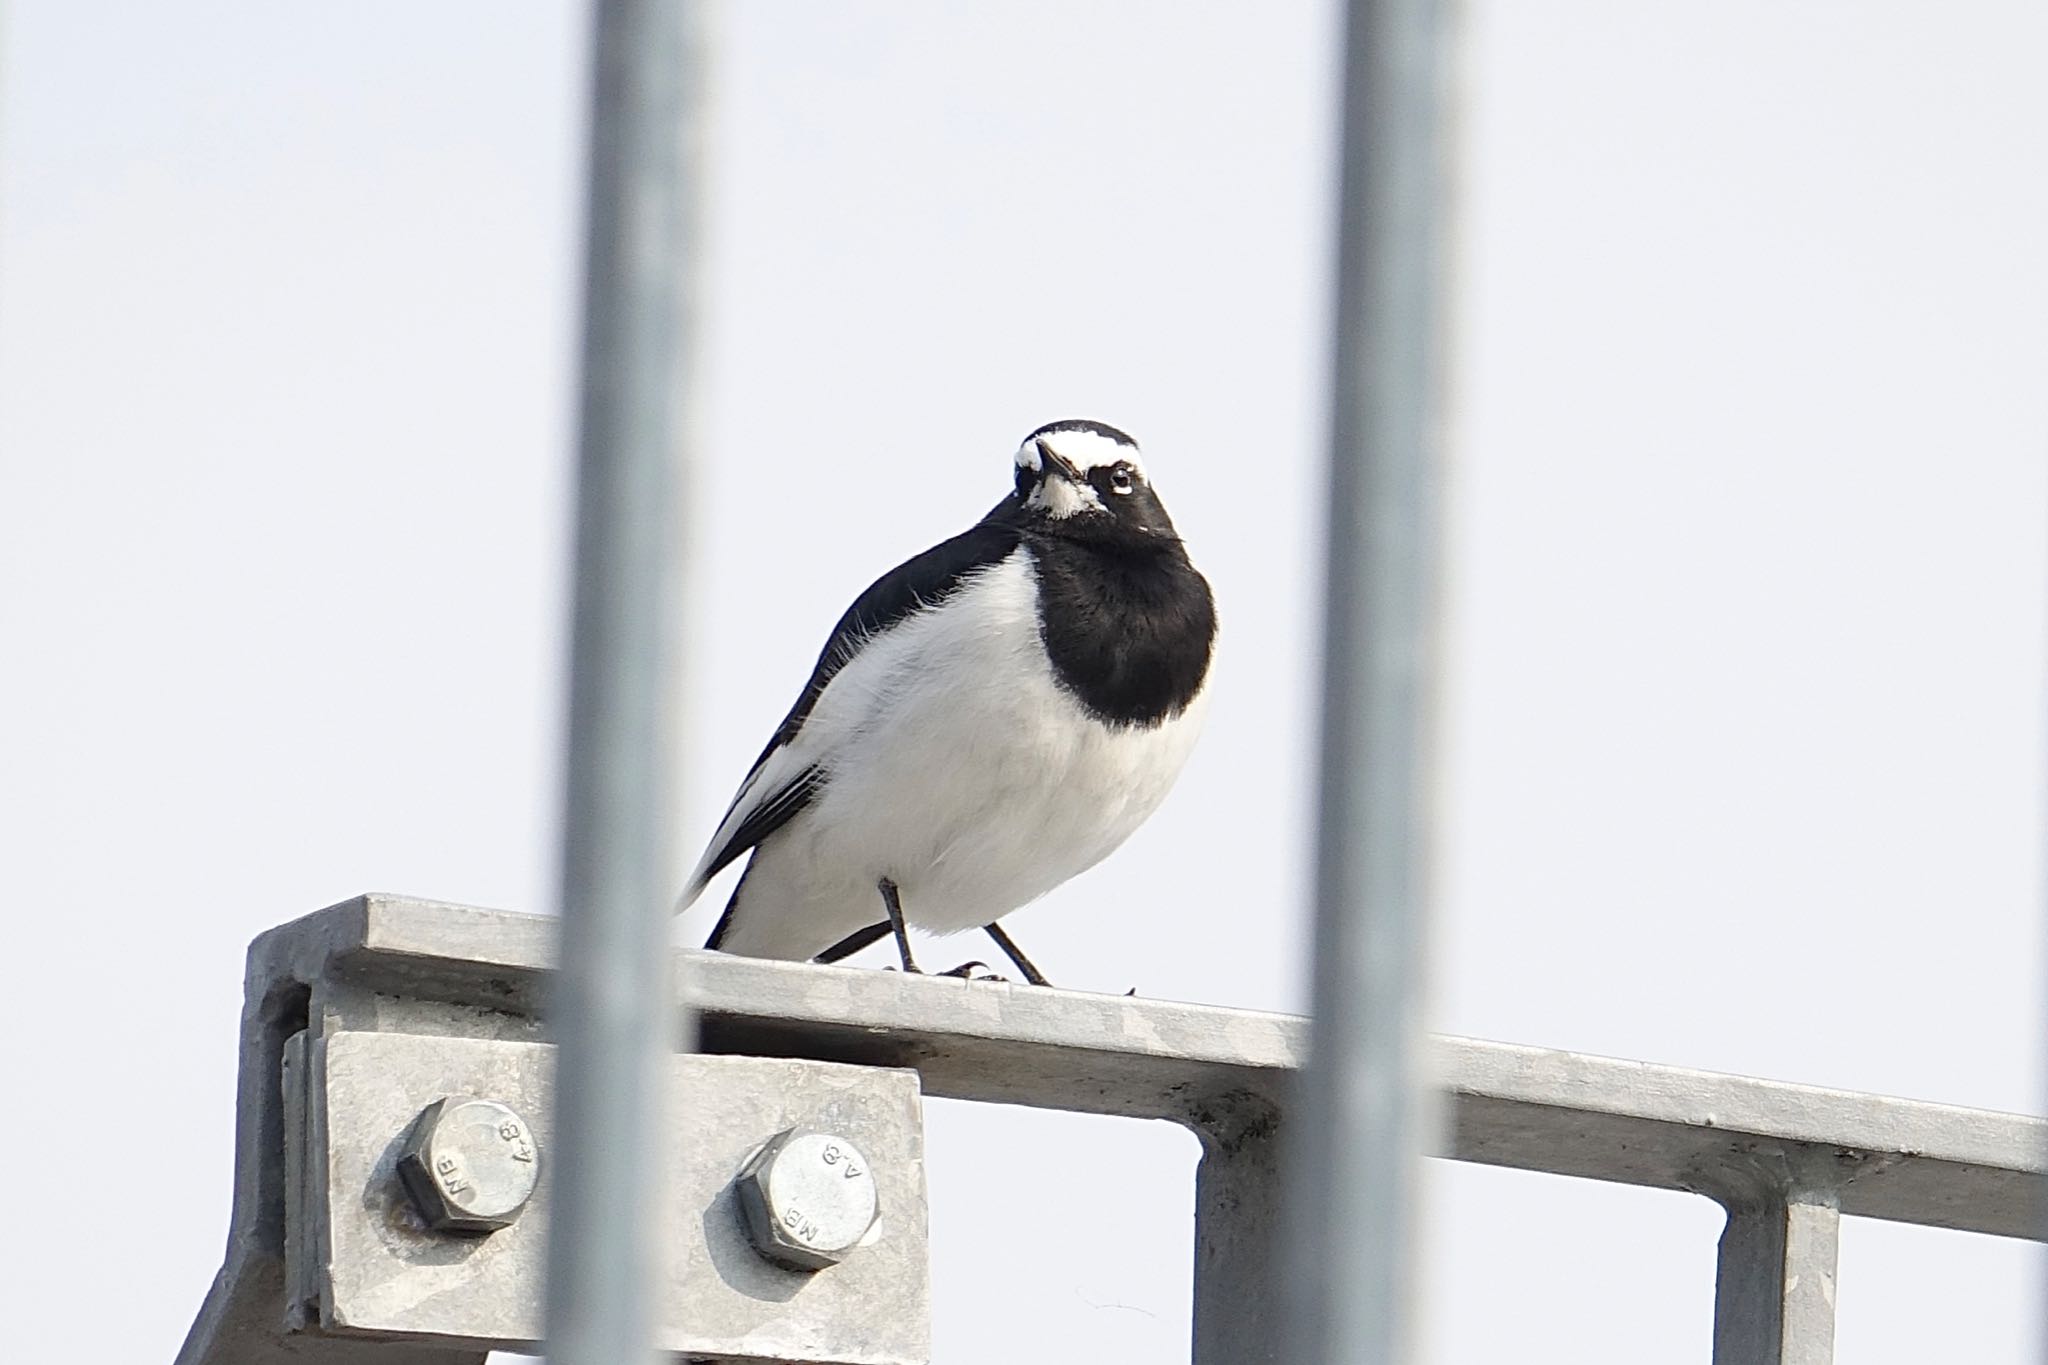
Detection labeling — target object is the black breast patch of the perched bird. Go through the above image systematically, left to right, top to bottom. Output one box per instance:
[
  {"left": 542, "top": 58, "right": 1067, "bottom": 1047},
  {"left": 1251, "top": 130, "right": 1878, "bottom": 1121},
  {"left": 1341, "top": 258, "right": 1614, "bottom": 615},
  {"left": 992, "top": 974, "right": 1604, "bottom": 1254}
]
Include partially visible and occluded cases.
[{"left": 1024, "top": 536, "right": 1217, "bottom": 726}]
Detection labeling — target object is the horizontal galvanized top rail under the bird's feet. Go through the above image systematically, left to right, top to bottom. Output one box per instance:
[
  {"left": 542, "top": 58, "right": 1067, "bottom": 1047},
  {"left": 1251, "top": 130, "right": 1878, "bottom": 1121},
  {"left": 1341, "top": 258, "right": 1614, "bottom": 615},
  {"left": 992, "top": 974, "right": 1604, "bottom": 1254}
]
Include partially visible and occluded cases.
[{"left": 288, "top": 896, "right": 2048, "bottom": 1240}]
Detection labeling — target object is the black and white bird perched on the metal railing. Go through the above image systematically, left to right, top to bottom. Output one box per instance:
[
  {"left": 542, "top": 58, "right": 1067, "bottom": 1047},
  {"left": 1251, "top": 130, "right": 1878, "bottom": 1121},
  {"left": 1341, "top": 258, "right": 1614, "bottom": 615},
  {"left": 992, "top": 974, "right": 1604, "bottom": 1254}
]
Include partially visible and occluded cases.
[{"left": 678, "top": 420, "right": 1217, "bottom": 984}]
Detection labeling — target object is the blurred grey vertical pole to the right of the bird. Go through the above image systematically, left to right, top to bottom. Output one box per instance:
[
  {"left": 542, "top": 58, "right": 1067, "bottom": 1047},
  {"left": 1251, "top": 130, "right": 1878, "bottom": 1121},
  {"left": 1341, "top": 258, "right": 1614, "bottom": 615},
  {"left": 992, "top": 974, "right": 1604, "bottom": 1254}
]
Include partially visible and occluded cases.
[{"left": 1282, "top": 0, "right": 1446, "bottom": 1365}]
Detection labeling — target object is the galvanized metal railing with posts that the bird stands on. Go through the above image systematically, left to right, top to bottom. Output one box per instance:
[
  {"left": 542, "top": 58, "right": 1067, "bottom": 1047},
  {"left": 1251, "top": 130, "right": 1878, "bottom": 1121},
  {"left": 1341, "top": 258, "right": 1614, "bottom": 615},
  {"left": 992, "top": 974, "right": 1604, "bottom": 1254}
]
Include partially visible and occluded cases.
[{"left": 178, "top": 896, "right": 2048, "bottom": 1365}]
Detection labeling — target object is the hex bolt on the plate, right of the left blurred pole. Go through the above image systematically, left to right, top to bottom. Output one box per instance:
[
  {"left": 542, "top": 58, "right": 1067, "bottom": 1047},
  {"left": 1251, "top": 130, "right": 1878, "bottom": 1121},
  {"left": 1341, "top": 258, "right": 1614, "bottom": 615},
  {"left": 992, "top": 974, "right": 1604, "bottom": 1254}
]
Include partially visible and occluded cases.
[{"left": 733, "top": 1128, "right": 881, "bottom": 1271}]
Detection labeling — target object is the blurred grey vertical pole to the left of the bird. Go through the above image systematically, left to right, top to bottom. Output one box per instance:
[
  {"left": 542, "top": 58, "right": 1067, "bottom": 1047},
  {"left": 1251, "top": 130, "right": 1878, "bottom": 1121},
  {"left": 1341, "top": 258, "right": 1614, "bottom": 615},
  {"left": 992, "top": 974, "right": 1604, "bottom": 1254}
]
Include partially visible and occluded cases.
[{"left": 547, "top": 0, "right": 700, "bottom": 1365}]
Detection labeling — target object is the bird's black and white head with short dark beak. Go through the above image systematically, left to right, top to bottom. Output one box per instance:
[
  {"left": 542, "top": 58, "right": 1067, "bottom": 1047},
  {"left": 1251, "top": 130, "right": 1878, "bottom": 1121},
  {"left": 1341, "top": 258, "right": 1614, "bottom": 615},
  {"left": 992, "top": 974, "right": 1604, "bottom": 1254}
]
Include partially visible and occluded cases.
[{"left": 1016, "top": 417, "right": 1178, "bottom": 542}]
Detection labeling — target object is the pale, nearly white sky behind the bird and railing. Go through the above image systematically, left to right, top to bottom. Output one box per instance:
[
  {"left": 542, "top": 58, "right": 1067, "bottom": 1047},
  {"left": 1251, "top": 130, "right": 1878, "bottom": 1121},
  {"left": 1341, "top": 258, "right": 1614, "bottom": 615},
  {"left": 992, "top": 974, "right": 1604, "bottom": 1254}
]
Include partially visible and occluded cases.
[{"left": 0, "top": 0, "right": 2048, "bottom": 1365}]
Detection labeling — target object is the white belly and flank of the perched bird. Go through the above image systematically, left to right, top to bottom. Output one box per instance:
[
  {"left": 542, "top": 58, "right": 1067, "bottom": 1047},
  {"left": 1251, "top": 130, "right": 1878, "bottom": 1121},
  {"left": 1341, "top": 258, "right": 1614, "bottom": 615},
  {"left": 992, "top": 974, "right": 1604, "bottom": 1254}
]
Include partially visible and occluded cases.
[{"left": 721, "top": 551, "right": 1206, "bottom": 958}]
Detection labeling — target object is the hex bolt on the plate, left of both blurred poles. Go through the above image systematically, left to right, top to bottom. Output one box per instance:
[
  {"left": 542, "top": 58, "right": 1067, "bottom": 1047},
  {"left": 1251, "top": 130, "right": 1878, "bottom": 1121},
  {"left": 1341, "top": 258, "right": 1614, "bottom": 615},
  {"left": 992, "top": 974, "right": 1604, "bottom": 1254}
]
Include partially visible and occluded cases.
[{"left": 397, "top": 1095, "right": 541, "bottom": 1234}]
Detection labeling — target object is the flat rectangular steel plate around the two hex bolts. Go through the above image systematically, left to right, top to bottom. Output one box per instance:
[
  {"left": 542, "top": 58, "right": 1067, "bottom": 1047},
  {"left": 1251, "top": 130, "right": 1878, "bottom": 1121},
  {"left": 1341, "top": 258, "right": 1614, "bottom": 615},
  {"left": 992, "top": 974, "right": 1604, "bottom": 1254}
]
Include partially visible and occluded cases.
[{"left": 305, "top": 1031, "right": 930, "bottom": 1365}]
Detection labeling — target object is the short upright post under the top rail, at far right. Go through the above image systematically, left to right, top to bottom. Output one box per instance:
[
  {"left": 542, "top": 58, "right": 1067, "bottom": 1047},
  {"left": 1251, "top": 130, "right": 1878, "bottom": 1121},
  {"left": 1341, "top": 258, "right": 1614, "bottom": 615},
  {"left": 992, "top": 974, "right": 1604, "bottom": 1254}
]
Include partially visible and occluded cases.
[{"left": 1714, "top": 1193, "right": 1841, "bottom": 1365}]
